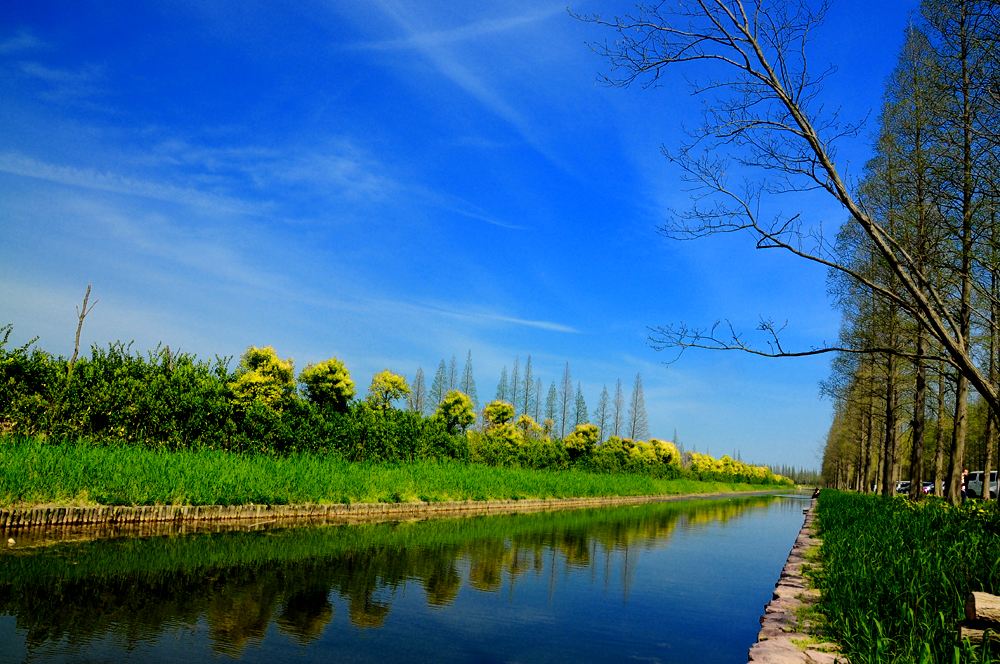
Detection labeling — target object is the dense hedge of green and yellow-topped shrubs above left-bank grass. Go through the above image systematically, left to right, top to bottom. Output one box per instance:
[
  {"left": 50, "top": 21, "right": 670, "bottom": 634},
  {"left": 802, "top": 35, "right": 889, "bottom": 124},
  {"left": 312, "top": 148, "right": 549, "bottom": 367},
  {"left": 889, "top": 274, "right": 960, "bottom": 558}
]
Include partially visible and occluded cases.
[{"left": 0, "top": 325, "right": 780, "bottom": 482}]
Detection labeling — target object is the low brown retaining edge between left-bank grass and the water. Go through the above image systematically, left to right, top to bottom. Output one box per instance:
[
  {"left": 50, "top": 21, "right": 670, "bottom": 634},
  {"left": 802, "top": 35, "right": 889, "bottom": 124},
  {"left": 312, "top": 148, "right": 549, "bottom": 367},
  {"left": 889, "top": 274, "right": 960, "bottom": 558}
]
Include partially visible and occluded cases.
[{"left": 0, "top": 491, "right": 775, "bottom": 533}]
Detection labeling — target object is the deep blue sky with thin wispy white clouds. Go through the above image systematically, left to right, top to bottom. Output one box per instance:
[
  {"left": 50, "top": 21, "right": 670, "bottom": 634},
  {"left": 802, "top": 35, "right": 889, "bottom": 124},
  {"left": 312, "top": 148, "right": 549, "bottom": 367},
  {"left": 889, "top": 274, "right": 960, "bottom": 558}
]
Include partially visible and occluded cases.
[{"left": 0, "top": 0, "right": 917, "bottom": 467}]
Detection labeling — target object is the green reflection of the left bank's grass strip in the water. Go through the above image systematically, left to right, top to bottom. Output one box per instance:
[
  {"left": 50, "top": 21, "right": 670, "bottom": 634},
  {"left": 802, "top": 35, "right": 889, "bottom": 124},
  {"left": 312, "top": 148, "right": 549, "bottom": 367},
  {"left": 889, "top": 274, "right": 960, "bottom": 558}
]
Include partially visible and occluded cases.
[{"left": 0, "top": 496, "right": 773, "bottom": 588}]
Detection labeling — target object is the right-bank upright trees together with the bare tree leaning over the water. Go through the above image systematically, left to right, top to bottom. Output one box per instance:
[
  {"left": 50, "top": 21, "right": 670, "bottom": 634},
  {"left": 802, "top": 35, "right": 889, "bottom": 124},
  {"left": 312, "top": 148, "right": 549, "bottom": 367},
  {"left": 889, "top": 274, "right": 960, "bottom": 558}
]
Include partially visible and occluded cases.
[{"left": 581, "top": 0, "right": 1000, "bottom": 501}]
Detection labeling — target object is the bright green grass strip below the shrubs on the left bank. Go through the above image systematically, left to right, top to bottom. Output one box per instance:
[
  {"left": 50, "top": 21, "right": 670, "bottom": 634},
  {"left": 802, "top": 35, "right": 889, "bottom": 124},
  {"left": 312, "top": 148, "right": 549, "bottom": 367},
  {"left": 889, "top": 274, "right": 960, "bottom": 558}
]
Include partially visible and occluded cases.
[{"left": 0, "top": 437, "right": 780, "bottom": 505}]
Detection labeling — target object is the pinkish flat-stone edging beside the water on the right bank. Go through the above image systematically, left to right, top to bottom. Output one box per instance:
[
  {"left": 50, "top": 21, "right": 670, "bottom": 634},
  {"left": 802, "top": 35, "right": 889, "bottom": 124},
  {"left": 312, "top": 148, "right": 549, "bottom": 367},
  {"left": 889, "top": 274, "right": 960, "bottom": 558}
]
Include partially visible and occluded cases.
[{"left": 748, "top": 500, "right": 848, "bottom": 664}]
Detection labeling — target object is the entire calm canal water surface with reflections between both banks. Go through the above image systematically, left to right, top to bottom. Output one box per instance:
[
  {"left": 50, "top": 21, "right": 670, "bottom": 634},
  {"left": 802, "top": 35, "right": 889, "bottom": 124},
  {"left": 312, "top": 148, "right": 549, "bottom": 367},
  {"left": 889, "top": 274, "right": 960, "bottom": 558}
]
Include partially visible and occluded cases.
[{"left": 0, "top": 496, "right": 807, "bottom": 663}]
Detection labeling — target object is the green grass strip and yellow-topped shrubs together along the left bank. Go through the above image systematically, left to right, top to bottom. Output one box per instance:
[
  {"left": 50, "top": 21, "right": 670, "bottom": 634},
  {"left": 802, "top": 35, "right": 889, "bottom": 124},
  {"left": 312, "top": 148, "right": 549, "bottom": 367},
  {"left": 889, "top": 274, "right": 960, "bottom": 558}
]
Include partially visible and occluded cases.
[{"left": 0, "top": 325, "right": 792, "bottom": 505}]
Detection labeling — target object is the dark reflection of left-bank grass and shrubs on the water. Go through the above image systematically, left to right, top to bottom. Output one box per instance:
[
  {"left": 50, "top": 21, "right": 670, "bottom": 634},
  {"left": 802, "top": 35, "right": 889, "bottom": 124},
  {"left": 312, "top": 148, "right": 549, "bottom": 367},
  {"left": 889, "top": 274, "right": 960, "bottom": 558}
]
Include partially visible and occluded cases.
[{"left": 0, "top": 496, "right": 802, "bottom": 661}]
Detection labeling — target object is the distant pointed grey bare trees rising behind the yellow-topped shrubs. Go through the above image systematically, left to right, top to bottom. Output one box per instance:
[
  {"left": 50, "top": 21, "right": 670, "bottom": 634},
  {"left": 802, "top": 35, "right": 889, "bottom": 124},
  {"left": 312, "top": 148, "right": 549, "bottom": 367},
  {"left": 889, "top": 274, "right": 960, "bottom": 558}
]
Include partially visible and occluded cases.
[{"left": 406, "top": 350, "right": 650, "bottom": 441}]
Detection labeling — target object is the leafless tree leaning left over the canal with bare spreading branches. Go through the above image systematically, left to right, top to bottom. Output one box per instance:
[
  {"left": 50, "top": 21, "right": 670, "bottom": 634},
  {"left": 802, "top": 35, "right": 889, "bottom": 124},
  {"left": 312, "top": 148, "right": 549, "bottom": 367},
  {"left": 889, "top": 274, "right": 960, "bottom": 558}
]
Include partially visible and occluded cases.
[{"left": 580, "top": 0, "right": 1000, "bottom": 499}]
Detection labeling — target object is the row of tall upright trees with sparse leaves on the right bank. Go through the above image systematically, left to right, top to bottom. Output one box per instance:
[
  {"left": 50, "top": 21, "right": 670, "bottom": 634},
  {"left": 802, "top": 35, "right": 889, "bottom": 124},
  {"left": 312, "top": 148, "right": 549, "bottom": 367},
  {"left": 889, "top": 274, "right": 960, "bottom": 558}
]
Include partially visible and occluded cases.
[{"left": 823, "top": 0, "right": 1000, "bottom": 499}]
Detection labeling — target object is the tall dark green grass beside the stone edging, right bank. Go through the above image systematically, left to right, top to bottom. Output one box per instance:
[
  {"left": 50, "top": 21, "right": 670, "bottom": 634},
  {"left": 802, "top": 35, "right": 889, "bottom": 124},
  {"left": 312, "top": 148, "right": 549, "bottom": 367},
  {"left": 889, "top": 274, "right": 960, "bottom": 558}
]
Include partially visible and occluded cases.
[{"left": 818, "top": 491, "right": 1000, "bottom": 664}]
